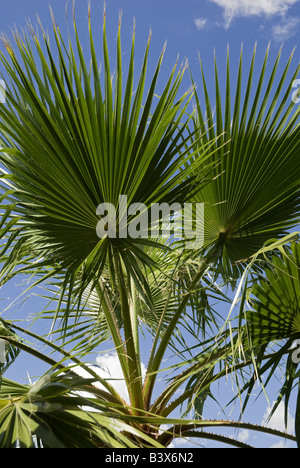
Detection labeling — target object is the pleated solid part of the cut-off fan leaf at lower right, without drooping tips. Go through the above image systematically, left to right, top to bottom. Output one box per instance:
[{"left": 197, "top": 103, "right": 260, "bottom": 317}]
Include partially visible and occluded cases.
[{"left": 247, "top": 243, "right": 300, "bottom": 345}]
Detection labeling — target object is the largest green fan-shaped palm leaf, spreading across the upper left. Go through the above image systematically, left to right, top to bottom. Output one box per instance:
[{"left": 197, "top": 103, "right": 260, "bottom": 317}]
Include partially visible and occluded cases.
[{"left": 0, "top": 8, "right": 209, "bottom": 286}]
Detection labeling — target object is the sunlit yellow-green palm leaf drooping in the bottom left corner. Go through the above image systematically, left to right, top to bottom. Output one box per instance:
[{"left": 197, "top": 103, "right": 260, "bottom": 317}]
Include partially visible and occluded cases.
[{"left": 0, "top": 375, "right": 163, "bottom": 448}]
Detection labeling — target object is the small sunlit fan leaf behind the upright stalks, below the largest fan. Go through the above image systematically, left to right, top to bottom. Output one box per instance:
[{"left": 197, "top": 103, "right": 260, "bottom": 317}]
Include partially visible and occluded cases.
[{"left": 37, "top": 247, "right": 219, "bottom": 353}]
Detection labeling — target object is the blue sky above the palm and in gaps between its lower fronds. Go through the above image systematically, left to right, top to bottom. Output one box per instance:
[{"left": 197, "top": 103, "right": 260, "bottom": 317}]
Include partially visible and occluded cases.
[{"left": 0, "top": 0, "right": 300, "bottom": 448}]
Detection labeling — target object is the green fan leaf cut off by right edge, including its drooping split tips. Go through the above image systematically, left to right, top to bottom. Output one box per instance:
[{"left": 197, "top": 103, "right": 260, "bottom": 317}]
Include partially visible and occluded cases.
[{"left": 230, "top": 241, "right": 300, "bottom": 442}]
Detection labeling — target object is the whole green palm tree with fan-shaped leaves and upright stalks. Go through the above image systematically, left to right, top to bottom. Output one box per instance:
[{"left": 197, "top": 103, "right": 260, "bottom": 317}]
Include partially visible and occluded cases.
[{"left": 0, "top": 3, "right": 300, "bottom": 448}]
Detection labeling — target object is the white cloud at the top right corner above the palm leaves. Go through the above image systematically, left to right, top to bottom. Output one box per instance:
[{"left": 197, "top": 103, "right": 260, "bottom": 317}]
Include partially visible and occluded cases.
[{"left": 210, "top": 0, "right": 299, "bottom": 29}]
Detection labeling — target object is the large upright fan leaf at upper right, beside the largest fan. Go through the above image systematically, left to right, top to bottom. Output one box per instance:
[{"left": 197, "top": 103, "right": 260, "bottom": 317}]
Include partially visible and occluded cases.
[{"left": 190, "top": 45, "right": 300, "bottom": 270}]
